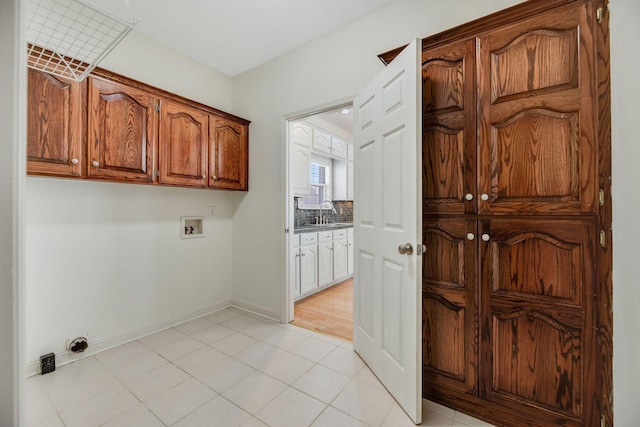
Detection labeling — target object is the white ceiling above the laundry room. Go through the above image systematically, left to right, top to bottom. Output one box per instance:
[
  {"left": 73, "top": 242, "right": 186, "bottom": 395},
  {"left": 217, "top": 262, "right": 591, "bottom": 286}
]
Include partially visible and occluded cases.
[{"left": 87, "top": 0, "right": 398, "bottom": 77}]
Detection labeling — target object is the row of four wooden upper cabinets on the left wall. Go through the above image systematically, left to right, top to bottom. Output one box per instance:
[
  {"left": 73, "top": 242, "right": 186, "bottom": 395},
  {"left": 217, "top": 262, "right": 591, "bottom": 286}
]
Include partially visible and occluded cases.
[{"left": 27, "top": 69, "right": 250, "bottom": 191}]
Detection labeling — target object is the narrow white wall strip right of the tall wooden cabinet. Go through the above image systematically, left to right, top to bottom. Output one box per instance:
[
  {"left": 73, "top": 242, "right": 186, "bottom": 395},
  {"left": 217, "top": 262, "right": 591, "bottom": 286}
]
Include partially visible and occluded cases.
[{"left": 610, "top": 0, "right": 640, "bottom": 426}]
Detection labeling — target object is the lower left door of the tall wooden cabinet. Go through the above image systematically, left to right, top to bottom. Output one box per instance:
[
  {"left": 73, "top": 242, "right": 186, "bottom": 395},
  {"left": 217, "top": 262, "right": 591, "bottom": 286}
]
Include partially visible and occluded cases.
[{"left": 422, "top": 219, "right": 478, "bottom": 396}]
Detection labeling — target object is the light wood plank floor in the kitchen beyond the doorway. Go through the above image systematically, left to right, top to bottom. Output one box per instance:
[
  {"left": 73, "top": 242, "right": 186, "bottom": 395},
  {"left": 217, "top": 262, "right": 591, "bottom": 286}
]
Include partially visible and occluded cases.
[{"left": 292, "top": 279, "right": 353, "bottom": 341}]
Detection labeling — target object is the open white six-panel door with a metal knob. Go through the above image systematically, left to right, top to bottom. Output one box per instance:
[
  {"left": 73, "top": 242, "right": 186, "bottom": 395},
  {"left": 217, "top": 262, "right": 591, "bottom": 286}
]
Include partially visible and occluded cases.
[{"left": 353, "top": 40, "right": 422, "bottom": 424}]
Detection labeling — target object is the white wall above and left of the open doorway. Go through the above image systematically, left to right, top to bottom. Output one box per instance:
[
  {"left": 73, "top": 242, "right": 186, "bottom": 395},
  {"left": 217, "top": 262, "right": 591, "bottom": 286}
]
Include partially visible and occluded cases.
[{"left": 233, "top": 0, "right": 520, "bottom": 319}]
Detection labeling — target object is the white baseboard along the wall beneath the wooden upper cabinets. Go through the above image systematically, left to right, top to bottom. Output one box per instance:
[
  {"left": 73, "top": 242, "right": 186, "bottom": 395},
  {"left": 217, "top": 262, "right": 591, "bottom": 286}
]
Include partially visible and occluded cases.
[{"left": 25, "top": 300, "right": 235, "bottom": 377}]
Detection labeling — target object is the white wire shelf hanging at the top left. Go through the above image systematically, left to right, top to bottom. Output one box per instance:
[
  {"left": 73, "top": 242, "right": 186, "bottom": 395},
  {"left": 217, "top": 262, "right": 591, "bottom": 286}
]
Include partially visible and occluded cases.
[{"left": 25, "top": 0, "right": 139, "bottom": 81}]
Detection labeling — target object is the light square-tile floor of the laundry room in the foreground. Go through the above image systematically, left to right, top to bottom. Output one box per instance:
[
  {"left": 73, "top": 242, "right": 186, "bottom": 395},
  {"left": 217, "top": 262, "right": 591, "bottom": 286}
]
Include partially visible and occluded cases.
[{"left": 25, "top": 309, "right": 490, "bottom": 427}]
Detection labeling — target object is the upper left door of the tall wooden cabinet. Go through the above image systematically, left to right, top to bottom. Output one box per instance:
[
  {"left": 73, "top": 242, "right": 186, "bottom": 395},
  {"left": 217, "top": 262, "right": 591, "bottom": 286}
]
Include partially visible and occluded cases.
[{"left": 422, "top": 41, "right": 476, "bottom": 214}]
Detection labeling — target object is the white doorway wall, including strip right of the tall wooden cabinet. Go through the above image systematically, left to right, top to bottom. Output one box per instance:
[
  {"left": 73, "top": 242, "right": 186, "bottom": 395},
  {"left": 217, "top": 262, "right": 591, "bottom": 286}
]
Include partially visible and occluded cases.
[{"left": 233, "top": 0, "right": 640, "bottom": 427}]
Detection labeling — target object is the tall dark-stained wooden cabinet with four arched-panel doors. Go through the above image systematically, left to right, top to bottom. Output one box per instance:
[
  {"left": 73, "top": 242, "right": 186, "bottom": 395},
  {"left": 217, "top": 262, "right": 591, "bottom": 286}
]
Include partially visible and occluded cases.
[{"left": 422, "top": 1, "right": 610, "bottom": 426}]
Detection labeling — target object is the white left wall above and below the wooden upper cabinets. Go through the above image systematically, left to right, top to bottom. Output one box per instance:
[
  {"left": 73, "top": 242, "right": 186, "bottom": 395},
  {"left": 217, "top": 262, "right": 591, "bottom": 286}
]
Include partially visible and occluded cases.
[{"left": 24, "top": 33, "right": 238, "bottom": 372}]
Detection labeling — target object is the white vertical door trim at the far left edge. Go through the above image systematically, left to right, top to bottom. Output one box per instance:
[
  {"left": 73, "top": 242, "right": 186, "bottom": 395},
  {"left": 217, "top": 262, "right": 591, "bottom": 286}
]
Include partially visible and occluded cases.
[{"left": 0, "top": 0, "right": 27, "bottom": 427}]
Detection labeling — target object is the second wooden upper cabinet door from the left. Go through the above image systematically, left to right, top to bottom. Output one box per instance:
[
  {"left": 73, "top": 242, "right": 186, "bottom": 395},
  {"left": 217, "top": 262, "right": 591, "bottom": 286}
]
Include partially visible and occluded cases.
[{"left": 87, "top": 77, "right": 158, "bottom": 182}]
